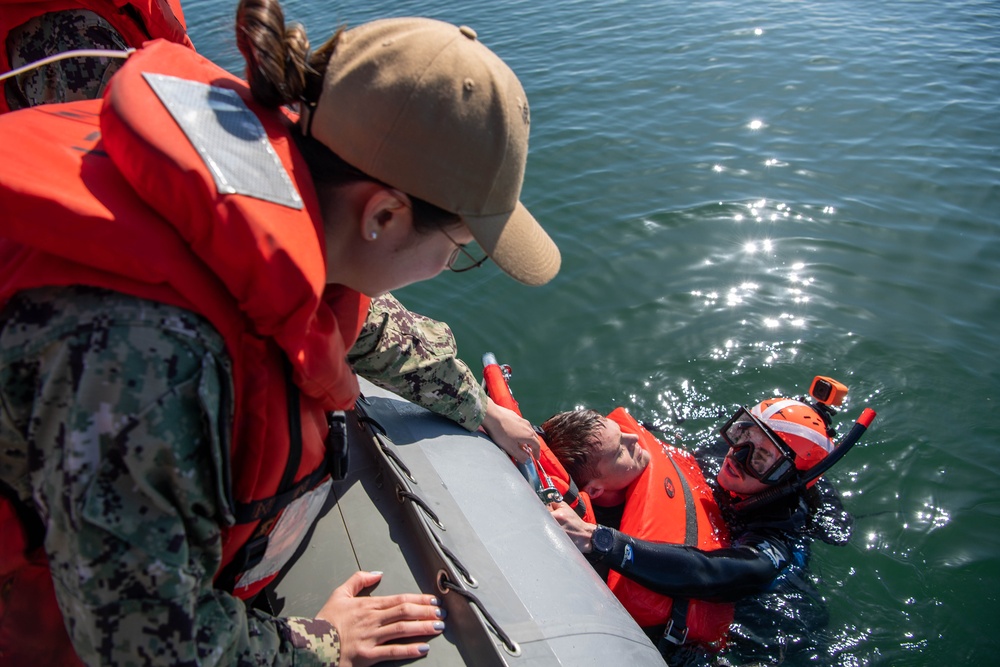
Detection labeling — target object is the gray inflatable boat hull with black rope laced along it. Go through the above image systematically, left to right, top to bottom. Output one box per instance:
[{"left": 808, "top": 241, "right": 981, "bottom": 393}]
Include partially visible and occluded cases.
[{"left": 274, "top": 380, "right": 663, "bottom": 667}]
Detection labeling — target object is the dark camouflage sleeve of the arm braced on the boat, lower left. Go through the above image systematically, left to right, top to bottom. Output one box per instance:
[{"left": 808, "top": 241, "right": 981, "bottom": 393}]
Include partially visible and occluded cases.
[{"left": 0, "top": 289, "right": 339, "bottom": 665}]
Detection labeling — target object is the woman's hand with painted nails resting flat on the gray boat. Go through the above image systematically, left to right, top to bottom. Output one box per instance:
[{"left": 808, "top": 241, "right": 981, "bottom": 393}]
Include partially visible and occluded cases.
[{"left": 316, "top": 572, "right": 445, "bottom": 667}]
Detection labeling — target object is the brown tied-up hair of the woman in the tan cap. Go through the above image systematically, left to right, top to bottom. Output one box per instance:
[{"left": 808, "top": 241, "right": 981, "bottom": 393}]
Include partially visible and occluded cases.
[{"left": 236, "top": 0, "right": 461, "bottom": 234}]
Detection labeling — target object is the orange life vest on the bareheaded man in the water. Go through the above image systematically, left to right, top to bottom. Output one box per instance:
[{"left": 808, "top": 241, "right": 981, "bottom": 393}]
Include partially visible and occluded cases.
[{"left": 608, "top": 408, "right": 733, "bottom": 644}]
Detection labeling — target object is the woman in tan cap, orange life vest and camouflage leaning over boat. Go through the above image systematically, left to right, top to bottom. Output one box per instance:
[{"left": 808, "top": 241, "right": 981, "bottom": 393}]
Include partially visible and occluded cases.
[{"left": 0, "top": 0, "right": 559, "bottom": 665}]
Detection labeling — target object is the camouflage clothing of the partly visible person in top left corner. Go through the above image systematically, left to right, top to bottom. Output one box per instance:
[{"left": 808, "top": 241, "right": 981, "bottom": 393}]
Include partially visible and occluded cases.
[{"left": 4, "top": 9, "right": 128, "bottom": 111}]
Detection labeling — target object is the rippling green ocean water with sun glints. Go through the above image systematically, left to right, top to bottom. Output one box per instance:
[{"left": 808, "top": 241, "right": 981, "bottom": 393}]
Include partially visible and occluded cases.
[{"left": 185, "top": 0, "right": 1000, "bottom": 665}]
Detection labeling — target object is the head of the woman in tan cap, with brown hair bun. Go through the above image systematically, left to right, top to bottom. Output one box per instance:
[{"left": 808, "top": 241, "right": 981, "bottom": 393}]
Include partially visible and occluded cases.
[{"left": 237, "top": 2, "right": 560, "bottom": 295}]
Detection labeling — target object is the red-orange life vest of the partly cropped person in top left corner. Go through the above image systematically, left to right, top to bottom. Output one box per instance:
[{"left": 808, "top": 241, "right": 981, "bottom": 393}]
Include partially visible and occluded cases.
[{"left": 0, "top": 0, "right": 194, "bottom": 114}]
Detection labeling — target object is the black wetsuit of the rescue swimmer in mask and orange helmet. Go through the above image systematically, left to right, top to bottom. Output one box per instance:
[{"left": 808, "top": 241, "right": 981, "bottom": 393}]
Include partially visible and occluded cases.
[{"left": 588, "top": 479, "right": 852, "bottom": 664}]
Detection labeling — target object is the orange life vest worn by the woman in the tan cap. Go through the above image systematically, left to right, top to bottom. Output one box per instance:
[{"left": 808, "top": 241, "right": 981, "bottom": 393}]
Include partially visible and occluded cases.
[{"left": 0, "top": 40, "right": 368, "bottom": 656}]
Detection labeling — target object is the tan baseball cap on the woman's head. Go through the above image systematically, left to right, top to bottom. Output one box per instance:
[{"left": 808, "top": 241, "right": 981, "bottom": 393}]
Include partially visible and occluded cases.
[{"left": 310, "top": 18, "right": 560, "bottom": 285}]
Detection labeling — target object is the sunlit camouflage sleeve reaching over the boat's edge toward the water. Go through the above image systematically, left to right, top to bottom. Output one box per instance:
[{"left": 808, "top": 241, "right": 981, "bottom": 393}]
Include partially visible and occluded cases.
[{"left": 348, "top": 294, "right": 486, "bottom": 431}]
